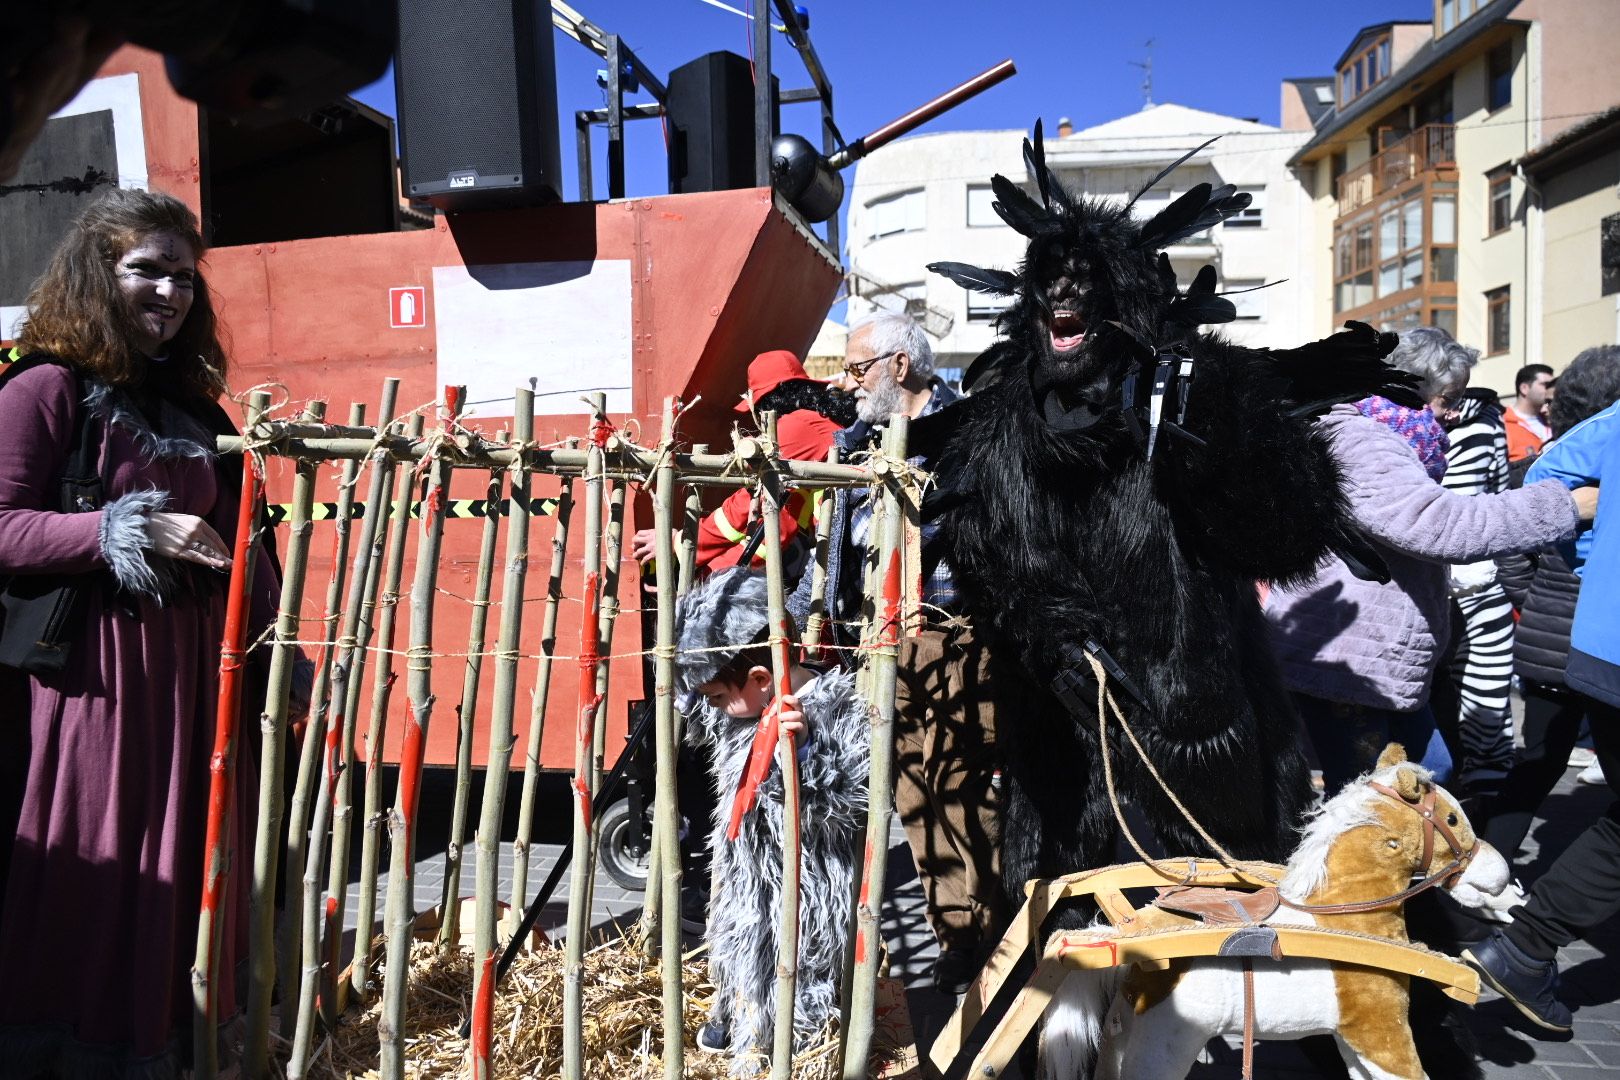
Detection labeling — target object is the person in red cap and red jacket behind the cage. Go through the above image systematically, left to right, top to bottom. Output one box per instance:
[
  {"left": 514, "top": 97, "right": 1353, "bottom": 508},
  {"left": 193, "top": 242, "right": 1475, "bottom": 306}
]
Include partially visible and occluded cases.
[{"left": 630, "top": 348, "right": 854, "bottom": 576}]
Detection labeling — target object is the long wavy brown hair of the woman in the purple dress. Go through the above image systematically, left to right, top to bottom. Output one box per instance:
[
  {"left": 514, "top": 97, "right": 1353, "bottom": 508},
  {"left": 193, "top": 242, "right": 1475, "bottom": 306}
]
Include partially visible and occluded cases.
[{"left": 16, "top": 188, "right": 225, "bottom": 400}]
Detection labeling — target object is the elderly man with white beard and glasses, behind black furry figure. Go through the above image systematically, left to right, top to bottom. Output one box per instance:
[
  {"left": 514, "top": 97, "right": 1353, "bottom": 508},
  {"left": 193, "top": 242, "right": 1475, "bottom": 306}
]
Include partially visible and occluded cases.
[{"left": 805, "top": 313, "right": 1006, "bottom": 994}]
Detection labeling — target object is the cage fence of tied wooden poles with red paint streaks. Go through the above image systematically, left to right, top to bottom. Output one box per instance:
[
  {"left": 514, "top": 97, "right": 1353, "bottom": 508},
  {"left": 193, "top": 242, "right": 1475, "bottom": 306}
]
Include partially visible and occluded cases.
[{"left": 193, "top": 379, "right": 919, "bottom": 1080}]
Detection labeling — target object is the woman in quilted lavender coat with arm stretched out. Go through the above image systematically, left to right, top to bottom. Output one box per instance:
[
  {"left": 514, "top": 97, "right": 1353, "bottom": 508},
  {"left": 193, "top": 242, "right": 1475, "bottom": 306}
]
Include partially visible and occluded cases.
[{"left": 1265, "top": 327, "right": 1596, "bottom": 795}]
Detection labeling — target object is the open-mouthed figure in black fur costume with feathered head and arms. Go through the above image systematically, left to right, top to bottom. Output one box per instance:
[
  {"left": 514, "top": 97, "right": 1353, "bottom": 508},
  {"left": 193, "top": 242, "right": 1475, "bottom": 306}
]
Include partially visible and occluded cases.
[{"left": 912, "top": 123, "right": 1422, "bottom": 1075}]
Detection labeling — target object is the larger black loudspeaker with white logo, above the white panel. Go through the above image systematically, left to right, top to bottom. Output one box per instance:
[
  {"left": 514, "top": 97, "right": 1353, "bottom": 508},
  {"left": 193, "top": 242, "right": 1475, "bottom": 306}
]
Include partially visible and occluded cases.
[{"left": 394, "top": 0, "right": 562, "bottom": 210}]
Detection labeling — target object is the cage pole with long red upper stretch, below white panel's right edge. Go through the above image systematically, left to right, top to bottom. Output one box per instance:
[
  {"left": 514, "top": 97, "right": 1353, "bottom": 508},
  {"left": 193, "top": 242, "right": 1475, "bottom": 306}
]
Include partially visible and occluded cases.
[{"left": 562, "top": 393, "right": 608, "bottom": 1080}]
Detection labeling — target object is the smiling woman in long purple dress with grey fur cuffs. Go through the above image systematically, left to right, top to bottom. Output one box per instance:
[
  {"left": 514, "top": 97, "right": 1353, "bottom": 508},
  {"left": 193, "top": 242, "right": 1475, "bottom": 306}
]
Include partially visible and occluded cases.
[{"left": 0, "top": 191, "right": 277, "bottom": 1078}]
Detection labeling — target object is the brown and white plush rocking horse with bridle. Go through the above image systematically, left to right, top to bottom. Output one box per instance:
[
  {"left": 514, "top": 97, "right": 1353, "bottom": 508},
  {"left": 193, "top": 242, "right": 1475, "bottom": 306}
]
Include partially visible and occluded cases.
[{"left": 1042, "top": 743, "right": 1521, "bottom": 1080}]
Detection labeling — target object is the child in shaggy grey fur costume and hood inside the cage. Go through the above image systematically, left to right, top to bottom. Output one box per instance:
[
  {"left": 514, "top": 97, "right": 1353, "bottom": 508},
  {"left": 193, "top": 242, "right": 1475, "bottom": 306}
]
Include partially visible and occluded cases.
[{"left": 679, "top": 570, "right": 870, "bottom": 1077}]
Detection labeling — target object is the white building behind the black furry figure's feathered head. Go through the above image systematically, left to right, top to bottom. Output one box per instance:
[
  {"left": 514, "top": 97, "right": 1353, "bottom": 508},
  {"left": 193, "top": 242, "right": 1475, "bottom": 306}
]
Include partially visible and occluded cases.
[{"left": 847, "top": 105, "right": 1315, "bottom": 375}]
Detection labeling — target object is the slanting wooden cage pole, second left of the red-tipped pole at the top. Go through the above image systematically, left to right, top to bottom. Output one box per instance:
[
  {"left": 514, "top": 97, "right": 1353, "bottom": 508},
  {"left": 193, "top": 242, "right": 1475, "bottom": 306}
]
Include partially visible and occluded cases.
[{"left": 321, "top": 379, "right": 400, "bottom": 1028}]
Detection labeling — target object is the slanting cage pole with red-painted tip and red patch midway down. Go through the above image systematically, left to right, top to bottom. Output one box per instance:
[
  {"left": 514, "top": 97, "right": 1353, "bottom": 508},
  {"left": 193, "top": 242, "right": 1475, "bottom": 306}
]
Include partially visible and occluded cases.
[{"left": 377, "top": 387, "right": 467, "bottom": 1080}]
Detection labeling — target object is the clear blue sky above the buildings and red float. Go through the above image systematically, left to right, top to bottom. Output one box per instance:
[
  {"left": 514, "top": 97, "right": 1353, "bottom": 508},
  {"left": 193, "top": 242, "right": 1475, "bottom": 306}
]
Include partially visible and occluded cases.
[{"left": 356, "top": 0, "right": 1432, "bottom": 236}]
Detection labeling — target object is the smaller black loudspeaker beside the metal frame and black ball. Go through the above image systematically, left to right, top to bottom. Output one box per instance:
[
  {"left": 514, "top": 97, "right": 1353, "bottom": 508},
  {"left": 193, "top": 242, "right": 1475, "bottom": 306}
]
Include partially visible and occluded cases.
[{"left": 664, "top": 52, "right": 781, "bottom": 193}]
